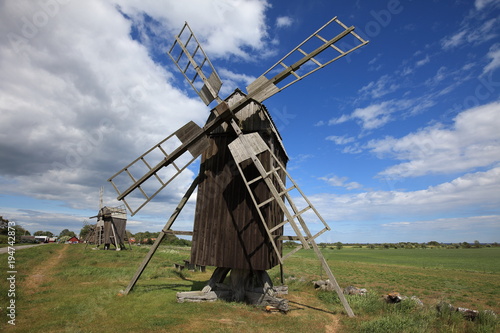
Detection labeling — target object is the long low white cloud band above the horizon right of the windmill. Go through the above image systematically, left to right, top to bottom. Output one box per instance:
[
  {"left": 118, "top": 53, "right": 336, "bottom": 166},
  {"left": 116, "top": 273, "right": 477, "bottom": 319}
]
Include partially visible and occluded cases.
[{"left": 309, "top": 167, "right": 500, "bottom": 224}]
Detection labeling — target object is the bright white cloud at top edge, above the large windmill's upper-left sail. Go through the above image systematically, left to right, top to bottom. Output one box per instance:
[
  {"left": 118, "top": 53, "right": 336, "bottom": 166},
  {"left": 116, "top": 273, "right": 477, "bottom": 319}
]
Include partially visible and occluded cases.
[{"left": 114, "top": 0, "right": 269, "bottom": 60}]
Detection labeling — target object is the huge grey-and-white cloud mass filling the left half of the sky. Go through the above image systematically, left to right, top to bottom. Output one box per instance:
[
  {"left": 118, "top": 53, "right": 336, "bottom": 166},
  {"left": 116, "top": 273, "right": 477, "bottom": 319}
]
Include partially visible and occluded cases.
[{"left": 0, "top": 0, "right": 274, "bottom": 218}]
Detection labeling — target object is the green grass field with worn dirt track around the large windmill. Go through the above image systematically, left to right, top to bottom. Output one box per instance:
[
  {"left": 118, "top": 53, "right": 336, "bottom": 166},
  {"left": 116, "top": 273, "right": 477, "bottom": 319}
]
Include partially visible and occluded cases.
[{"left": 0, "top": 244, "right": 500, "bottom": 332}]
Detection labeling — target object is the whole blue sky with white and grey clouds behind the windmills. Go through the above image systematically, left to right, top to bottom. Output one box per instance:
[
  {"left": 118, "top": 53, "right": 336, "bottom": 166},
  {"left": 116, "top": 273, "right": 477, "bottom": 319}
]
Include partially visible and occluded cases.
[{"left": 0, "top": 0, "right": 500, "bottom": 243}]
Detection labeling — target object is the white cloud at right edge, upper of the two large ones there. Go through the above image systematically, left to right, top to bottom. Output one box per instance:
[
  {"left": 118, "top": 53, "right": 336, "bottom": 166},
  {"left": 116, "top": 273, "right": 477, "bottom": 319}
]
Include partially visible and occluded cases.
[{"left": 366, "top": 102, "right": 500, "bottom": 178}]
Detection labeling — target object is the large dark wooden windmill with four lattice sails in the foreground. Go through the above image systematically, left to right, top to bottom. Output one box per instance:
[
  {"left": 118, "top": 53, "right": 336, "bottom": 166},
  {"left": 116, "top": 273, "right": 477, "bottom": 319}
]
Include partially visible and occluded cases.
[{"left": 109, "top": 17, "right": 368, "bottom": 316}]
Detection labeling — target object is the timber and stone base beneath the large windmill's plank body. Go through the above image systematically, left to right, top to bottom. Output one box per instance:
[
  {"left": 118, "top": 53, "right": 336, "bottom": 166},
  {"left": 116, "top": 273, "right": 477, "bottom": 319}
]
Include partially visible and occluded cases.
[{"left": 177, "top": 267, "right": 289, "bottom": 312}]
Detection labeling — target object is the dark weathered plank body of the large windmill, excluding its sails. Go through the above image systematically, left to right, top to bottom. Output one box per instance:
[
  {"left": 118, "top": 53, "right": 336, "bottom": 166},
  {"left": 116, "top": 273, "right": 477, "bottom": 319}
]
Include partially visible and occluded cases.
[{"left": 191, "top": 91, "right": 288, "bottom": 270}]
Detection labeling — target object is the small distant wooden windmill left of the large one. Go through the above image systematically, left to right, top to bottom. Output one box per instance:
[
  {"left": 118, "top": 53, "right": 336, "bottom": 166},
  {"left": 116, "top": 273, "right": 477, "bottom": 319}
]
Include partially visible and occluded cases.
[{"left": 86, "top": 187, "right": 128, "bottom": 251}]
